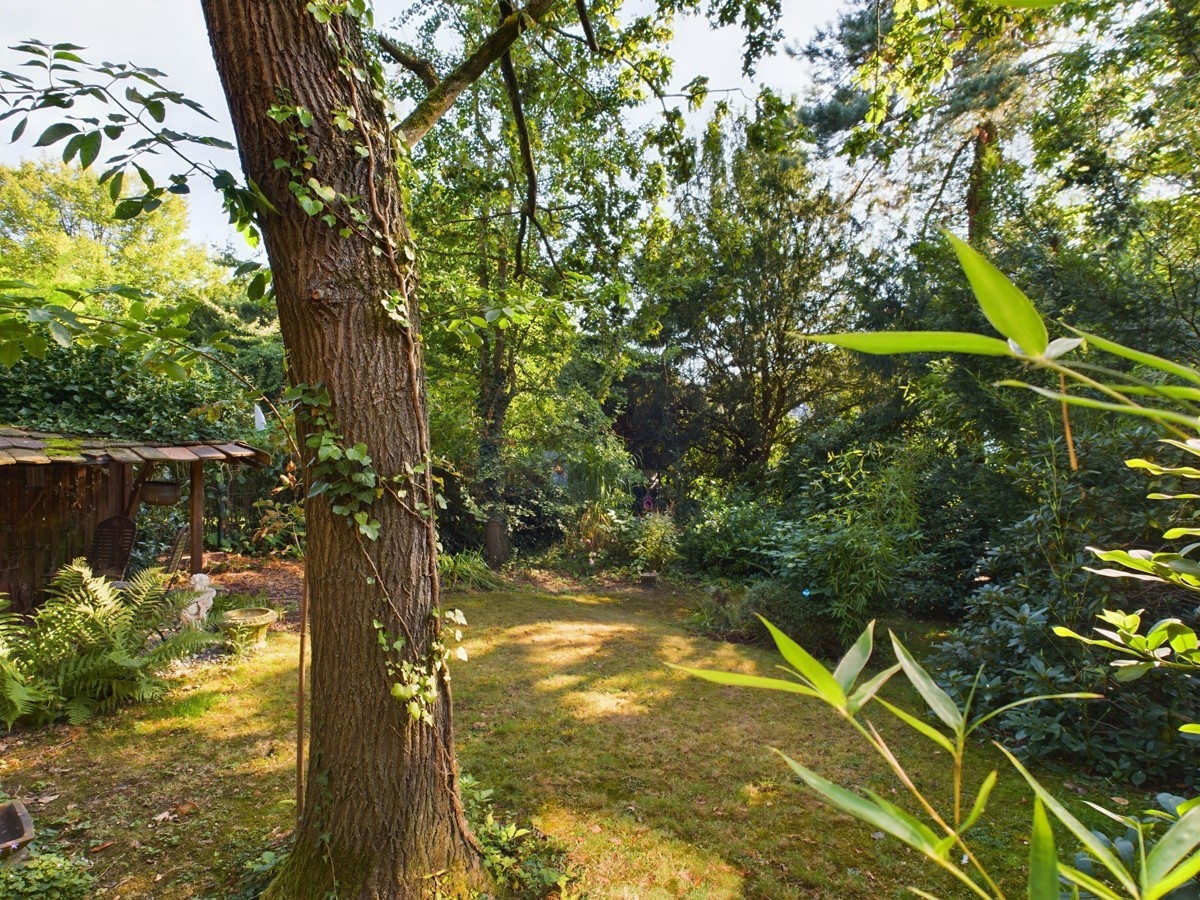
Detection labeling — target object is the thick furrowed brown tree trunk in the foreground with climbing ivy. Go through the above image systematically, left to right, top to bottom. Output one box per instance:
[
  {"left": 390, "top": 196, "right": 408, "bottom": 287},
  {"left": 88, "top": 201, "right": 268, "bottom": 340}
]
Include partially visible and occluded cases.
[{"left": 203, "top": 0, "right": 482, "bottom": 898}]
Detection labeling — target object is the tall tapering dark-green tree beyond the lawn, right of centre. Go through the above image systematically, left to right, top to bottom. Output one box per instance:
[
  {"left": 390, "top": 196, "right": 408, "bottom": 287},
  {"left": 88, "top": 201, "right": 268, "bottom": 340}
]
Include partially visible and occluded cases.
[{"left": 643, "top": 94, "right": 854, "bottom": 478}]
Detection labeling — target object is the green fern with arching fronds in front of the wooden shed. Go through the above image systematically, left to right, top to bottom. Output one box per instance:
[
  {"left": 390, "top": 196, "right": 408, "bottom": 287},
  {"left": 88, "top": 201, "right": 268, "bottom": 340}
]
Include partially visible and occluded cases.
[{"left": 0, "top": 559, "right": 212, "bottom": 728}]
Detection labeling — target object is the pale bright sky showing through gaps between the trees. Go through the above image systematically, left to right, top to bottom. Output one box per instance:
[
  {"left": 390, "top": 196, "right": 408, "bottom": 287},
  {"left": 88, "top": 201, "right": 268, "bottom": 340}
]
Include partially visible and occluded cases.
[{"left": 0, "top": 0, "right": 841, "bottom": 247}]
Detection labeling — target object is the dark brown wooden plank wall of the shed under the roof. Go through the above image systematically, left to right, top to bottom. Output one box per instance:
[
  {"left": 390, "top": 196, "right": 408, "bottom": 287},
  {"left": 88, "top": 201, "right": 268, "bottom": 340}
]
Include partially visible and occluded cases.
[{"left": 0, "top": 463, "right": 127, "bottom": 611}]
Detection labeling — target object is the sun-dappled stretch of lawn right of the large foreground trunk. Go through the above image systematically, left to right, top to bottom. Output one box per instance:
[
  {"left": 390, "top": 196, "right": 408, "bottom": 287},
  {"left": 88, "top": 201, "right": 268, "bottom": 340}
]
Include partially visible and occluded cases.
[{"left": 455, "top": 594, "right": 1027, "bottom": 898}]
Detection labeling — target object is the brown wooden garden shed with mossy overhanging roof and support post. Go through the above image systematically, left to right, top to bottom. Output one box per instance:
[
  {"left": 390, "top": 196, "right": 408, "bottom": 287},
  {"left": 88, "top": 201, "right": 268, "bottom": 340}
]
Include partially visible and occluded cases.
[{"left": 0, "top": 427, "right": 271, "bottom": 610}]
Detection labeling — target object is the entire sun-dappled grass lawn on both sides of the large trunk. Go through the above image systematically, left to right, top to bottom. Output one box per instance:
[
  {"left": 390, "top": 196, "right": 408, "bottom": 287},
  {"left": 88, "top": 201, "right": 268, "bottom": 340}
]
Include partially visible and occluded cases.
[{"left": 0, "top": 578, "right": 1123, "bottom": 899}]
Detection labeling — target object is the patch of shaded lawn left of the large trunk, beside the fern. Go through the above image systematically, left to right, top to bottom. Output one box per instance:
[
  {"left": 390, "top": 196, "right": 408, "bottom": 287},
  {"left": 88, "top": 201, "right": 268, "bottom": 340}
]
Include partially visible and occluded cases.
[{"left": 4, "top": 635, "right": 298, "bottom": 898}]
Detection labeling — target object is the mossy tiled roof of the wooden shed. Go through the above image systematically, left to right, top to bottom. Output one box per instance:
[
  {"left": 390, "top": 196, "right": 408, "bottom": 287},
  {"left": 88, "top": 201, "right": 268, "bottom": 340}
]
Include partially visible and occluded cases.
[{"left": 0, "top": 426, "right": 271, "bottom": 466}]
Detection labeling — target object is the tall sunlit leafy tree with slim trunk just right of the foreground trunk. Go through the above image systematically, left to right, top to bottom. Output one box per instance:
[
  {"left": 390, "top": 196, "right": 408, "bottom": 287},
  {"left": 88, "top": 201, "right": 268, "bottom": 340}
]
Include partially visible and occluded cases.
[{"left": 384, "top": 4, "right": 696, "bottom": 566}]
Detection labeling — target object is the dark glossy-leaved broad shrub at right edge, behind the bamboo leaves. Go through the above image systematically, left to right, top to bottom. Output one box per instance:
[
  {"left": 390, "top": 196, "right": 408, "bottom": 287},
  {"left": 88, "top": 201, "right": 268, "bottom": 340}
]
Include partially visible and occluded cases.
[{"left": 934, "top": 422, "right": 1200, "bottom": 785}]
